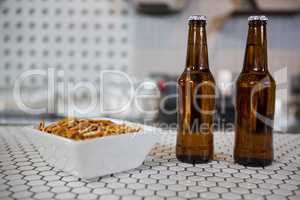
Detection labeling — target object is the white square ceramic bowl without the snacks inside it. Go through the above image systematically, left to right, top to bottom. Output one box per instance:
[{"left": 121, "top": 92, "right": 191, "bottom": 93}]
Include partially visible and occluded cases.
[{"left": 24, "top": 119, "right": 158, "bottom": 179}]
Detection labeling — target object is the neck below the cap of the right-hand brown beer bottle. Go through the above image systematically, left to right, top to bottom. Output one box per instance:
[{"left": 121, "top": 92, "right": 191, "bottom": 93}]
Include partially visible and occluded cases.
[{"left": 243, "top": 21, "right": 268, "bottom": 72}]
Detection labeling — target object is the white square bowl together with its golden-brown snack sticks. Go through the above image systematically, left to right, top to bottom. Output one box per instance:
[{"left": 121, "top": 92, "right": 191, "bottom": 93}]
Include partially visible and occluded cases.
[{"left": 21, "top": 117, "right": 160, "bottom": 178}]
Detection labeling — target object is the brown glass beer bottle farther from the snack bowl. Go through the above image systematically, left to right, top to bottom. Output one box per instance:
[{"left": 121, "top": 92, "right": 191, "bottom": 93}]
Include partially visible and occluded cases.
[{"left": 234, "top": 16, "right": 276, "bottom": 166}]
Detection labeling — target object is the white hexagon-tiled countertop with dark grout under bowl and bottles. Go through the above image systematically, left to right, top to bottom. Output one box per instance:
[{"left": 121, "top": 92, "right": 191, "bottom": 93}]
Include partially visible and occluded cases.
[{"left": 0, "top": 127, "right": 300, "bottom": 200}]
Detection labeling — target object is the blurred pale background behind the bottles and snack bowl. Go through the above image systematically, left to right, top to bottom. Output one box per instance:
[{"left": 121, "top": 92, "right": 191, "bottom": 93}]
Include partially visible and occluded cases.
[{"left": 0, "top": 0, "right": 300, "bottom": 132}]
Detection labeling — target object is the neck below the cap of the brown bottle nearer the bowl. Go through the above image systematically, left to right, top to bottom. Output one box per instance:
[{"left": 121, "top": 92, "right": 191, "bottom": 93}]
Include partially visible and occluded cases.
[{"left": 186, "top": 21, "right": 209, "bottom": 70}]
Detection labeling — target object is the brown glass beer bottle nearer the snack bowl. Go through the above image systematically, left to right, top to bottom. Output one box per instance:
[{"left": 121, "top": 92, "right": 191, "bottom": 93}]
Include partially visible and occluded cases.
[{"left": 176, "top": 15, "right": 215, "bottom": 164}]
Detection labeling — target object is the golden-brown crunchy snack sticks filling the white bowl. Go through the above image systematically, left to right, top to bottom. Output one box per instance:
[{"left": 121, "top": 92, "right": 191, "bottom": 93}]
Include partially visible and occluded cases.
[{"left": 38, "top": 118, "right": 141, "bottom": 140}]
